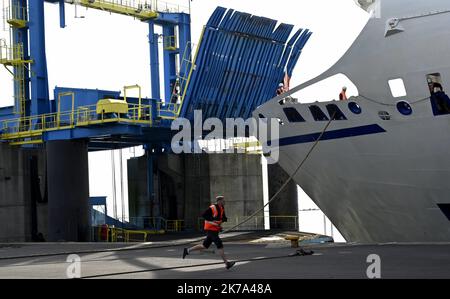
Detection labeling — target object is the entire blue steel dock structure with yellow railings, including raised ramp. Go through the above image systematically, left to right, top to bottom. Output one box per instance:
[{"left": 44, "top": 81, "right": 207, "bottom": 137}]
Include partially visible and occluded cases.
[{"left": 0, "top": 0, "right": 312, "bottom": 243}]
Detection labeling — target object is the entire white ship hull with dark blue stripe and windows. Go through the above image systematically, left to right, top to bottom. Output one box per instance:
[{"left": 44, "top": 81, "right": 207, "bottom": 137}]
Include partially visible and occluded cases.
[{"left": 254, "top": 0, "right": 450, "bottom": 243}]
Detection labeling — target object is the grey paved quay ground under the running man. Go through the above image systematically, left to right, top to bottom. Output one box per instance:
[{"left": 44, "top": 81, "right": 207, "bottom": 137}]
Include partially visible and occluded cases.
[{"left": 0, "top": 233, "right": 450, "bottom": 279}]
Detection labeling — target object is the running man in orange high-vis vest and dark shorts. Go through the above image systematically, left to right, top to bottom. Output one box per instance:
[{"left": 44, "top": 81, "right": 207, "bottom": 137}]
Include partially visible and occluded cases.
[{"left": 183, "top": 196, "right": 235, "bottom": 269}]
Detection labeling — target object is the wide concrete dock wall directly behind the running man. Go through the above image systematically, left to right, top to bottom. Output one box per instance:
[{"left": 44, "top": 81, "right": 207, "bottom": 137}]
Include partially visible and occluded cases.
[{"left": 128, "top": 154, "right": 264, "bottom": 230}]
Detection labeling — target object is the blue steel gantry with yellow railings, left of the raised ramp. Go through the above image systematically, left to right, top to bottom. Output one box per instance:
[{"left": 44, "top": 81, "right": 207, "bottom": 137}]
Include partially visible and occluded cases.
[{"left": 0, "top": 0, "right": 191, "bottom": 145}]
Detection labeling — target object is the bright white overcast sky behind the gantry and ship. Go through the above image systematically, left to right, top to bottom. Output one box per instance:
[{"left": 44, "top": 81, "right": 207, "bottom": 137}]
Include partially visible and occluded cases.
[{"left": 0, "top": 0, "right": 368, "bottom": 243}]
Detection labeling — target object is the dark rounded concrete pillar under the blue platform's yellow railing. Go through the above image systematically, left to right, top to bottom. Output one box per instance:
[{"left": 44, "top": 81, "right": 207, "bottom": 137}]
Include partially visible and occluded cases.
[{"left": 47, "top": 140, "right": 91, "bottom": 242}]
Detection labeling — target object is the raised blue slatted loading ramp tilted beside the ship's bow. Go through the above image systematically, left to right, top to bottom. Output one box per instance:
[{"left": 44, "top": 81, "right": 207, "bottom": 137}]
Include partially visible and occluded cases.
[{"left": 180, "top": 7, "right": 312, "bottom": 119}]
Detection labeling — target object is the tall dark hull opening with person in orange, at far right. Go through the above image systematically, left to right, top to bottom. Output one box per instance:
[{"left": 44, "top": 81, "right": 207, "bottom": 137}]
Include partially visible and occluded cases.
[{"left": 427, "top": 73, "right": 450, "bottom": 116}]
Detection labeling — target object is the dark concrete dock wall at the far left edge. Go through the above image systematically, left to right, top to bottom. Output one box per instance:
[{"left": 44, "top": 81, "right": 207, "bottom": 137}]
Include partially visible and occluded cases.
[{"left": 0, "top": 143, "right": 47, "bottom": 242}]
